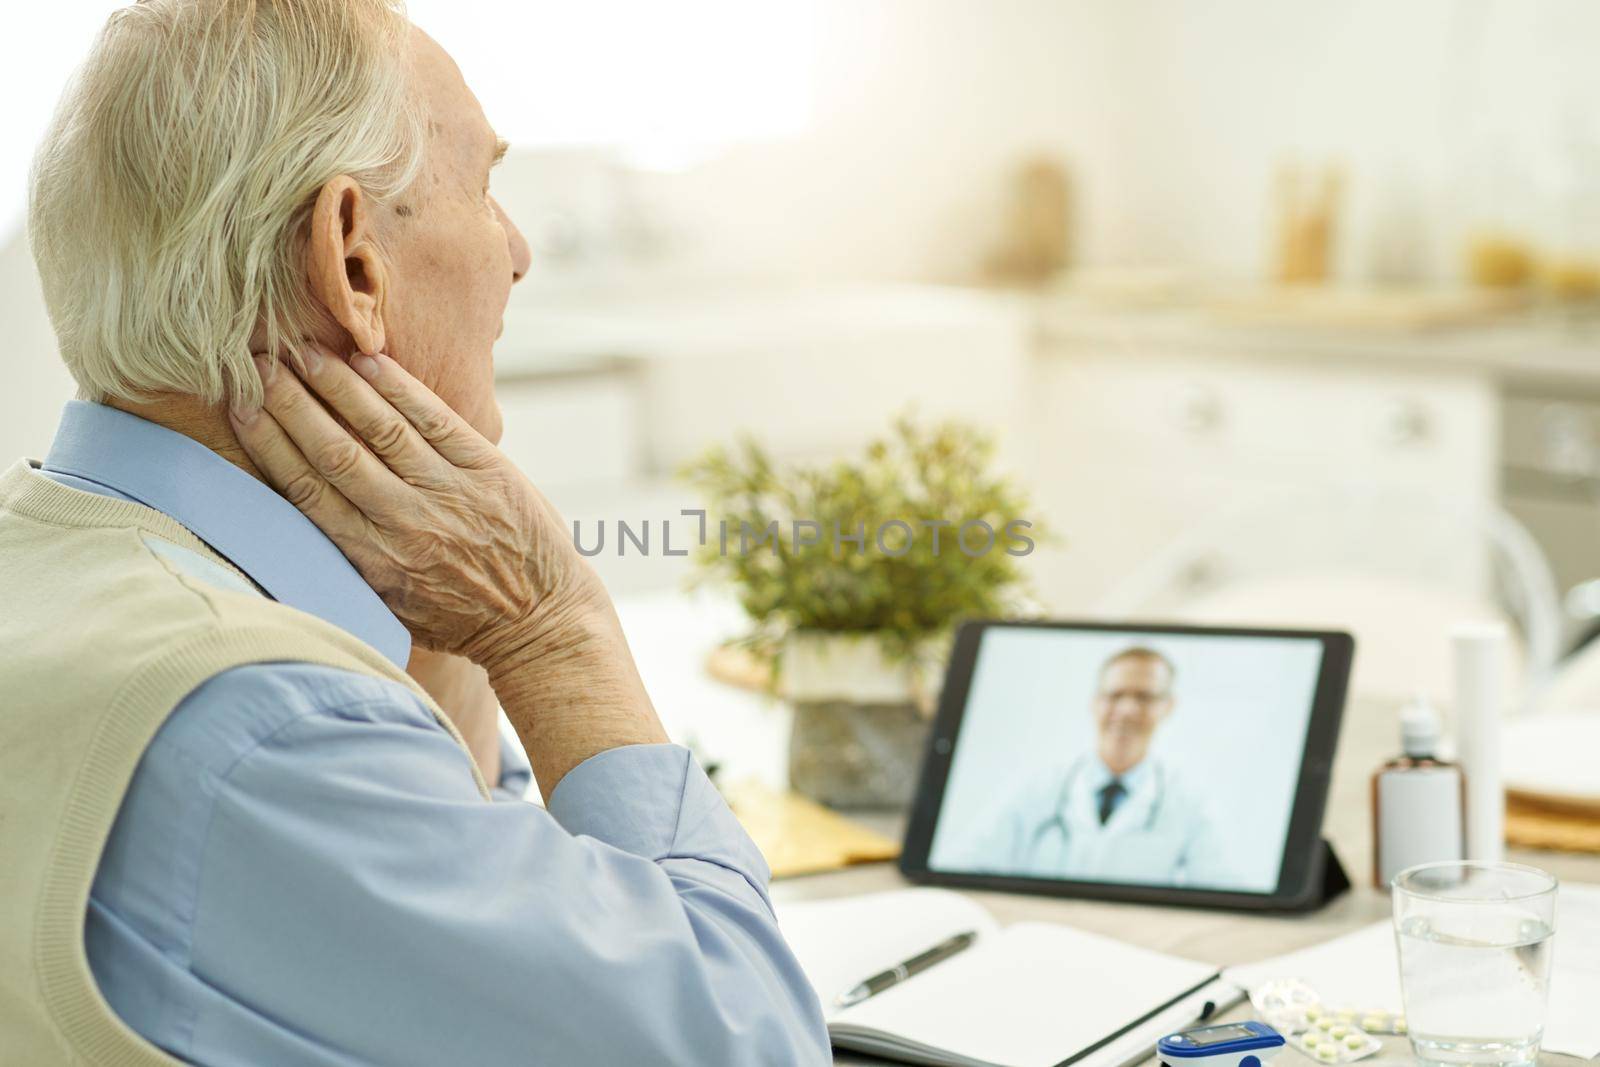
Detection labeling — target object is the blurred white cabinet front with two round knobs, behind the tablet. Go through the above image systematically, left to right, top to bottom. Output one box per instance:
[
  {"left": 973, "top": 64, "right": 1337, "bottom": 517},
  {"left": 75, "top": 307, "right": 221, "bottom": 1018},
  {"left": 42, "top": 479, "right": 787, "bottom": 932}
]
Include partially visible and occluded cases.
[{"left": 1029, "top": 336, "right": 1498, "bottom": 613}]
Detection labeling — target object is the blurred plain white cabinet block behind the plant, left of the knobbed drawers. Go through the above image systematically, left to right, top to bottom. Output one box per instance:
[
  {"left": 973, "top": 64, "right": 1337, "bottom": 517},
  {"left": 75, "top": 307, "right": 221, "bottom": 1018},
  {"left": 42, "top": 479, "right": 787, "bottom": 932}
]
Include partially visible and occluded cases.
[{"left": 496, "top": 285, "right": 1032, "bottom": 593}]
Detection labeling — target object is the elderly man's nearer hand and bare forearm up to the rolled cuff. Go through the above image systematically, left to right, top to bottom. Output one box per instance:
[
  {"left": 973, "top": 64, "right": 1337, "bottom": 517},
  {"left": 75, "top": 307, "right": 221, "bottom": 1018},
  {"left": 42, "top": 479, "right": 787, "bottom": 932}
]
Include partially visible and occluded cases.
[{"left": 232, "top": 349, "right": 666, "bottom": 797}]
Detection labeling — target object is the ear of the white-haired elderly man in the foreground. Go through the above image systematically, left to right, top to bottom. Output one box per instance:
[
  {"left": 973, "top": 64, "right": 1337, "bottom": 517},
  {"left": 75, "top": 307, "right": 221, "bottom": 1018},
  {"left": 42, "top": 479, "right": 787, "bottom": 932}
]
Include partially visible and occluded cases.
[{"left": 306, "top": 174, "right": 389, "bottom": 355}]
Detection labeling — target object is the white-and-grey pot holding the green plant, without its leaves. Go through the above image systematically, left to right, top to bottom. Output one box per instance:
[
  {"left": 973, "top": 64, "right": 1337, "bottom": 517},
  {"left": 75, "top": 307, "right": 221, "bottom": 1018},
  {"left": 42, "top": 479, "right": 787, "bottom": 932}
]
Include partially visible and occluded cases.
[{"left": 781, "top": 632, "right": 933, "bottom": 811}]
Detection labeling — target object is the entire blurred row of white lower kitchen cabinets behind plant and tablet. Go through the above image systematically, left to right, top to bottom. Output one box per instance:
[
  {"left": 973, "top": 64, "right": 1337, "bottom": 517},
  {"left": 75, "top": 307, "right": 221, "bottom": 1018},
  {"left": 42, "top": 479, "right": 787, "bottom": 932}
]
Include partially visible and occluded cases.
[{"left": 498, "top": 285, "right": 1600, "bottom": 646}]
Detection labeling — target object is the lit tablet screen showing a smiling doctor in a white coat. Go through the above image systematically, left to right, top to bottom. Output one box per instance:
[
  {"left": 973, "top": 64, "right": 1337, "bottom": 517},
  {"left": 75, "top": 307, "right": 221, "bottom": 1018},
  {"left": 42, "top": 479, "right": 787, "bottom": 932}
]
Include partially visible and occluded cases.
[{"left": 928, "top": 625, "right": 1323, "bottom": 893}]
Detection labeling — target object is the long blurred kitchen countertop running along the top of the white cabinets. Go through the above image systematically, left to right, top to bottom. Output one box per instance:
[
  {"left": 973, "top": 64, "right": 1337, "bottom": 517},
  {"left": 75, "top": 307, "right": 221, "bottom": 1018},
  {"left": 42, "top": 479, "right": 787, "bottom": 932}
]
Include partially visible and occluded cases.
[{"left": 496, "top": 283, "right": 1600, "bottom": 394}]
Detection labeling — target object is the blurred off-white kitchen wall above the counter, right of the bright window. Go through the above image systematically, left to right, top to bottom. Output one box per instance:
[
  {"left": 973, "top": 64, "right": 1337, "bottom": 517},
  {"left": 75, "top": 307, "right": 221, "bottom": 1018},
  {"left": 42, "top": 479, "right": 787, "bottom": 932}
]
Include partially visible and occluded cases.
[{"left": 504, "top": 0, "right": 1600, "bottom": 298}]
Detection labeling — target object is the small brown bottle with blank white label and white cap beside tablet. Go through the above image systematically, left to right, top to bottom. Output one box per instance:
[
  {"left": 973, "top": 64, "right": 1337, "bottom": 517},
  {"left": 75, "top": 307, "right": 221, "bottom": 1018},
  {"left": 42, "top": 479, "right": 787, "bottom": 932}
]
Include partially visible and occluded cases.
[{"left": 1373, "top": 699, "right": 1466, "bottom": 888}]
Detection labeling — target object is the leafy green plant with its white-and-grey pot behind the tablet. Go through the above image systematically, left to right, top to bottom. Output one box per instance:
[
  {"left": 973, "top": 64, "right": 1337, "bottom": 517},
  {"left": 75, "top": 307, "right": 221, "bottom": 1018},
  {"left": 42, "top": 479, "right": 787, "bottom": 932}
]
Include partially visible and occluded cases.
[{"left": 685, "top": 416, "right": 1040, "bottom": 808}]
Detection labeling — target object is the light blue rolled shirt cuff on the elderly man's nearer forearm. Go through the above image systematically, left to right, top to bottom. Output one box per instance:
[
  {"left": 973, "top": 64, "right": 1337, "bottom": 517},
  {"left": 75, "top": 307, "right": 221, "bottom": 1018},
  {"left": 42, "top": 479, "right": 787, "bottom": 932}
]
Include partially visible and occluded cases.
[{"left": 549, "top": 744, "right": 771, "bottom": 893}]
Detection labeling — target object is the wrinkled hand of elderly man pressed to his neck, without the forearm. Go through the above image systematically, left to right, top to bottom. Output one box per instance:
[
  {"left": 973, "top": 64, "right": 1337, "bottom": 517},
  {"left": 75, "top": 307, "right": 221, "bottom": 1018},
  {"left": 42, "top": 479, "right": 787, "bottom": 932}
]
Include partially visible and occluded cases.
[{"left": 230, "top": 349, "right": 592, "bottom": 664}]
